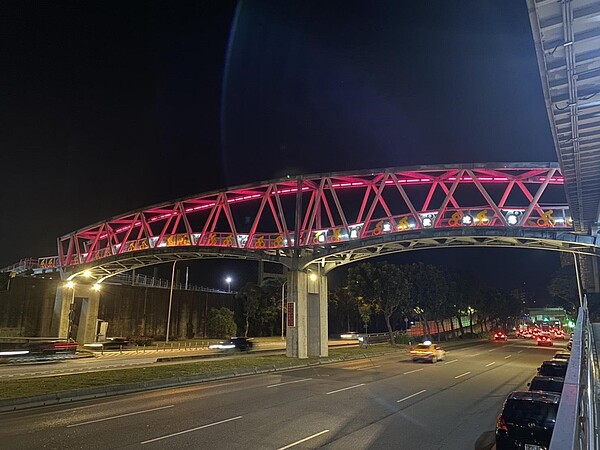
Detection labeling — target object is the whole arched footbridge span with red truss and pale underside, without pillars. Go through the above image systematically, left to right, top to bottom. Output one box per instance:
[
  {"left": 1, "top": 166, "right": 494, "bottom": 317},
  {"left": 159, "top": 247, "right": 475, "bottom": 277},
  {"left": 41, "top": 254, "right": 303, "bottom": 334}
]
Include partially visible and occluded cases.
[{"left": 45, "top": 163, "right": 595, "bottom": 282}]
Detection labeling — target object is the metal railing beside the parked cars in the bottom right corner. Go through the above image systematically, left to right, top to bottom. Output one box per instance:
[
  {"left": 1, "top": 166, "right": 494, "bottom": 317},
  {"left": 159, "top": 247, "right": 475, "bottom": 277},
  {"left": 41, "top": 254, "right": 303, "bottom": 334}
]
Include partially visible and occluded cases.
[{"left": 550, "top": 300, "right": 598, "bottom": 450}]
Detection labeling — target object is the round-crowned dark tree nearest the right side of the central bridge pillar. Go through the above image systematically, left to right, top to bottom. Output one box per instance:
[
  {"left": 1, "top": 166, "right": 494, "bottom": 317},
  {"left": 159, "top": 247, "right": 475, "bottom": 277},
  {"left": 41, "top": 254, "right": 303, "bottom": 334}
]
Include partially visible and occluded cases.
[{"left": 348, "top": 262, "right": 409, "bottom": 345}]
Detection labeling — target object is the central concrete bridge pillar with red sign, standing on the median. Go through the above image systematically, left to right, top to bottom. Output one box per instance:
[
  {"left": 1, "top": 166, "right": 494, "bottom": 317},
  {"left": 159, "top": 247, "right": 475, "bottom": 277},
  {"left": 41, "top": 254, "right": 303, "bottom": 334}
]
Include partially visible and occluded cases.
[{"left": 286, "top": 267, "right": 329, "bottom": 358}]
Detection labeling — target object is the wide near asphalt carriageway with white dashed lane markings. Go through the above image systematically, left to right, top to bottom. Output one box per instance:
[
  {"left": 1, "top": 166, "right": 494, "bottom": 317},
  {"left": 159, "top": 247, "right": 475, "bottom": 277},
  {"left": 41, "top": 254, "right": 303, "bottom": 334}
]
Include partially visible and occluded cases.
[{"left": 0, "top": 339, "right": 564, "bottom": 450}]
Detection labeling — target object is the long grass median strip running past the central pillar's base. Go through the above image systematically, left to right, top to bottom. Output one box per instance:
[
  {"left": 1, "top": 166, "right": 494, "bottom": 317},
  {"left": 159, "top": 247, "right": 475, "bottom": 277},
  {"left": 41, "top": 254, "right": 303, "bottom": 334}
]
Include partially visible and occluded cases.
[{"left": 0, "top": 344, "right": 405, "bottom": 400}]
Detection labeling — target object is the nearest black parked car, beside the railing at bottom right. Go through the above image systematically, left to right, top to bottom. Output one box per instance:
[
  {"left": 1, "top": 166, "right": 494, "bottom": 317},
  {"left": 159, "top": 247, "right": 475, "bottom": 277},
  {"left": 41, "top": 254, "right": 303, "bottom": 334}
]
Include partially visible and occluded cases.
[{"left": 496, "top": 391, "right": 560, "bottom": 450}]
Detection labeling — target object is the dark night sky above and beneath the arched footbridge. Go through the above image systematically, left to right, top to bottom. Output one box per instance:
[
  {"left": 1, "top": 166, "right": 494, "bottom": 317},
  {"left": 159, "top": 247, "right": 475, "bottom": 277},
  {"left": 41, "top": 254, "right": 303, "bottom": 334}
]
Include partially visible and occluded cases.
[{"left": 0, "top": 0, "right": 558, "bottom": 298}]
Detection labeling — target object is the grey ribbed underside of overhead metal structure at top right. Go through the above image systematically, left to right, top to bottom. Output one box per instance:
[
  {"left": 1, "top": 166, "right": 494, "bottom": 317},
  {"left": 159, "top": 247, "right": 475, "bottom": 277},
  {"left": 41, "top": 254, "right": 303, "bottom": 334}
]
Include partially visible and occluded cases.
[{"left": 527, "top": 0, "right": 600, "bottom": 234}]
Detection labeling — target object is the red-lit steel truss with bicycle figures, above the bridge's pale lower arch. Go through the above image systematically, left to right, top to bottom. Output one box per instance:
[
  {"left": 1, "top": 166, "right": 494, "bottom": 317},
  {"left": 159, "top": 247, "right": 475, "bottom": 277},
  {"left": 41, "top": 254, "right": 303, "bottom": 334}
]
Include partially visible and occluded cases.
[{"left": 52, "top": 163, "right": 572, "bottom": 268}]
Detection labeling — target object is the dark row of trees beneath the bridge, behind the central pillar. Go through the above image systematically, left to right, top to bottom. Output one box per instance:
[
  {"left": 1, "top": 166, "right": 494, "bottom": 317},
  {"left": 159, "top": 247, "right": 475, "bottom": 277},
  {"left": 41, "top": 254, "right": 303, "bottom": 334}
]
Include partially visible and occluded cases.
[{"left": 208, "top": 262, "right": 573, "bottom": 342}]
